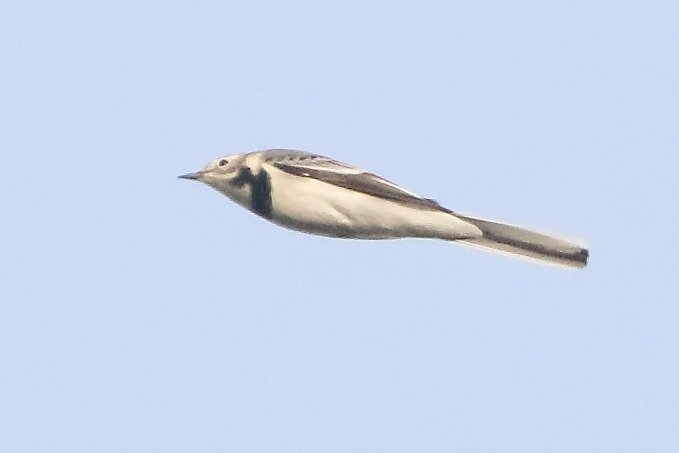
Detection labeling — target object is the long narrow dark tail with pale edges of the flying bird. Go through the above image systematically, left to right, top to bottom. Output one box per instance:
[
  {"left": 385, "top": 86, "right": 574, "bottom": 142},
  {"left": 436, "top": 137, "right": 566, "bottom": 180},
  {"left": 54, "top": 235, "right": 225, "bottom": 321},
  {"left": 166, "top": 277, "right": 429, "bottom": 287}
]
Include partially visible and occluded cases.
[{"left": 455, "top": 213, "right": 589, "bottom": 269}]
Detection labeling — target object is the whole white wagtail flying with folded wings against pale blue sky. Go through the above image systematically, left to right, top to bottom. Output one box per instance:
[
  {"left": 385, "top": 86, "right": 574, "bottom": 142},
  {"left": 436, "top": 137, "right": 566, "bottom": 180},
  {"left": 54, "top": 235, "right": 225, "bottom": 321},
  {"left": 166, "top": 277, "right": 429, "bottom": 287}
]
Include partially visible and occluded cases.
[{"left": 179, "top": 149, "right": 589, "bottom": 268}]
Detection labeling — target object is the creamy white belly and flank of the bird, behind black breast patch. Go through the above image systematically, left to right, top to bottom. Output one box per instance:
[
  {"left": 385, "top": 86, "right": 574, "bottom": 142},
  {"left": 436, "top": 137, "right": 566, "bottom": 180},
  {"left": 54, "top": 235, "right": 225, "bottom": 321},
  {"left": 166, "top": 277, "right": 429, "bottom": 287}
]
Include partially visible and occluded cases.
[{"left": 263, "top": 164, "right": 482, "bottom": 240}]
